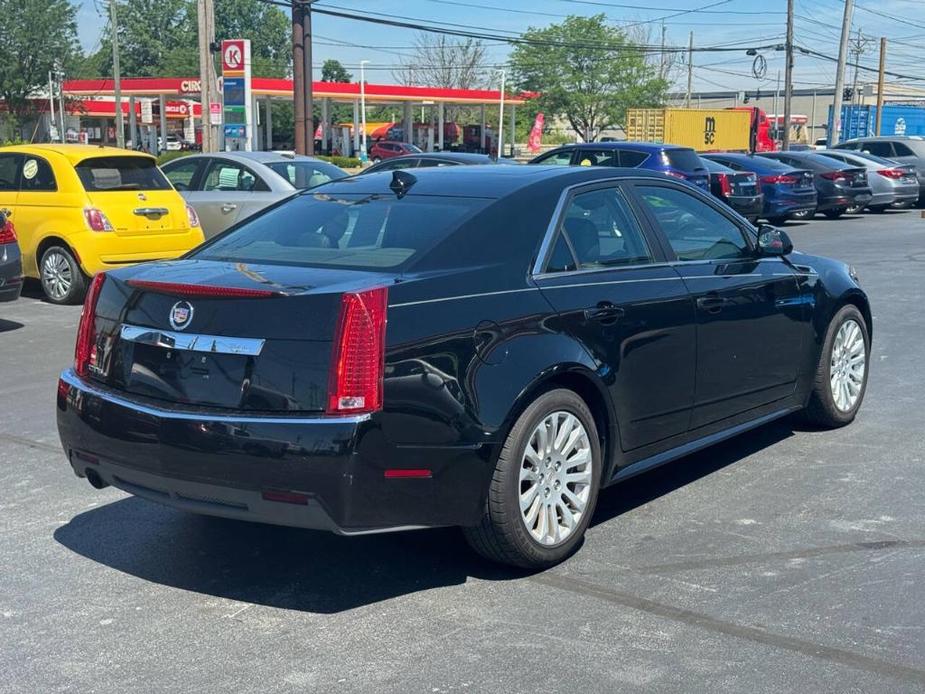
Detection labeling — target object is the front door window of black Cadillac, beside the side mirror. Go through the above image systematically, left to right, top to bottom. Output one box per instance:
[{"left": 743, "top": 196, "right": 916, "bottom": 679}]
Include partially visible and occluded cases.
[{"left": 638, "top": 186, "right": 751, "bottom": 260}]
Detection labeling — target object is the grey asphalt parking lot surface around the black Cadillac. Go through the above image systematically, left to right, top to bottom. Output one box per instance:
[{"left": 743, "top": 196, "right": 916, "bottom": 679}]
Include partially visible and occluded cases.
[{"left": 0, "top": 210, "right": 925, "bottom": 693}]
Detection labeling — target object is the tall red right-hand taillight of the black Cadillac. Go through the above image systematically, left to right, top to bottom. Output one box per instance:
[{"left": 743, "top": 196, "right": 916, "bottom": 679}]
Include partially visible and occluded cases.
[{"left": 328, "top": 287, "right": 389, "bottom": 414}]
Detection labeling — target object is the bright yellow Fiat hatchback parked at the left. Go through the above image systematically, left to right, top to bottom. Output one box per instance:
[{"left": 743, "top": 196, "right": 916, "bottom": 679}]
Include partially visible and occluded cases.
[{"left": 0, "top": 145, "right": 203, "bottom": 304}]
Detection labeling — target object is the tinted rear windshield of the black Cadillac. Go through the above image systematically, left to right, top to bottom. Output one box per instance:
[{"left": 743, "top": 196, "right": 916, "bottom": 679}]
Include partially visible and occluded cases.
[{"left": 191, "top": 192, "right": 492, "bottom": 270}]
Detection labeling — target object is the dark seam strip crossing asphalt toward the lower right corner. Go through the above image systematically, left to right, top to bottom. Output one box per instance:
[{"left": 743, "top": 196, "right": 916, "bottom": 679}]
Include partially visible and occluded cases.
[{"left": 528, "top": 571, "right": 925, "bottom": 685}]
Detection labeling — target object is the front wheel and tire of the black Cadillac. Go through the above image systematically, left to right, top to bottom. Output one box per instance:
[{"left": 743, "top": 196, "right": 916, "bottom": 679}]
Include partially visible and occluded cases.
[{"left": 804, "top": 304, "right": 870, "bottom": 429}]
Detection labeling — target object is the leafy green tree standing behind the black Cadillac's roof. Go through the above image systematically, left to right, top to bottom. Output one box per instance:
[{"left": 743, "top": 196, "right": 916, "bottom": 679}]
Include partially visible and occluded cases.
[{"left": 511, "top": 14, "right": 669, "bottom": 142}]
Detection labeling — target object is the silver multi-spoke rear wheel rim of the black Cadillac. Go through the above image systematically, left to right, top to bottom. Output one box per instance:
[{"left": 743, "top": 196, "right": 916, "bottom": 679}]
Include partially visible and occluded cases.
[{"left": 518, "top": 411, "right": 594, "bottom": 547}]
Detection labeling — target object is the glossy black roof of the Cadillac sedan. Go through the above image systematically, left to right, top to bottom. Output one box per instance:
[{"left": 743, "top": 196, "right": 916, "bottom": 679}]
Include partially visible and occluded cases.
[{"left": 318, "top": 164, "right": 666, "bottom": 198}]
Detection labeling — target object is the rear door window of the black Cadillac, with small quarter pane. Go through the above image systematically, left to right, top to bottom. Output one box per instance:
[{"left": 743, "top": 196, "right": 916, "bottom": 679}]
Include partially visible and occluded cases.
[{"left": 549, "top": 188, "right": 652, "bottom": 271}]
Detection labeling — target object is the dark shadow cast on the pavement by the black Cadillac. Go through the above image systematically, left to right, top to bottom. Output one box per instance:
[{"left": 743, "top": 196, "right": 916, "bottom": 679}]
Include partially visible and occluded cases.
[{"left": 54, "top": 420, "right": 793, "bottom": 614}]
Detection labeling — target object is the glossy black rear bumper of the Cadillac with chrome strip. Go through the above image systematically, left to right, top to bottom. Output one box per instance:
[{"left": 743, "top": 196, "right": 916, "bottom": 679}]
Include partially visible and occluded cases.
[{"left": 57, "top": 370, "right": 490, "bottom": 535}]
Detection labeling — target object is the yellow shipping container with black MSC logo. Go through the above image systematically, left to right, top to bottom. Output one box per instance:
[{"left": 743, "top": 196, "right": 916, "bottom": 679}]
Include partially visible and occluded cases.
[{"left": 625, "top": 108, "right": 752, "bottom": 152}]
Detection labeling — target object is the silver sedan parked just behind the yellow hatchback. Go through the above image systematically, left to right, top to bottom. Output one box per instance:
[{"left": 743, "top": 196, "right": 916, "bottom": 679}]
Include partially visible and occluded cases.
[{"left": 163, "top": 152, "right": 347, "bottom": 238}]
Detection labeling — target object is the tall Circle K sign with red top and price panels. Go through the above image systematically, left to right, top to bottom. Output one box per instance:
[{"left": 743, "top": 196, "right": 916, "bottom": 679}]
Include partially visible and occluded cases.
[{"left": 222, "top": 39, "right": 254, "bottom": 152}]
